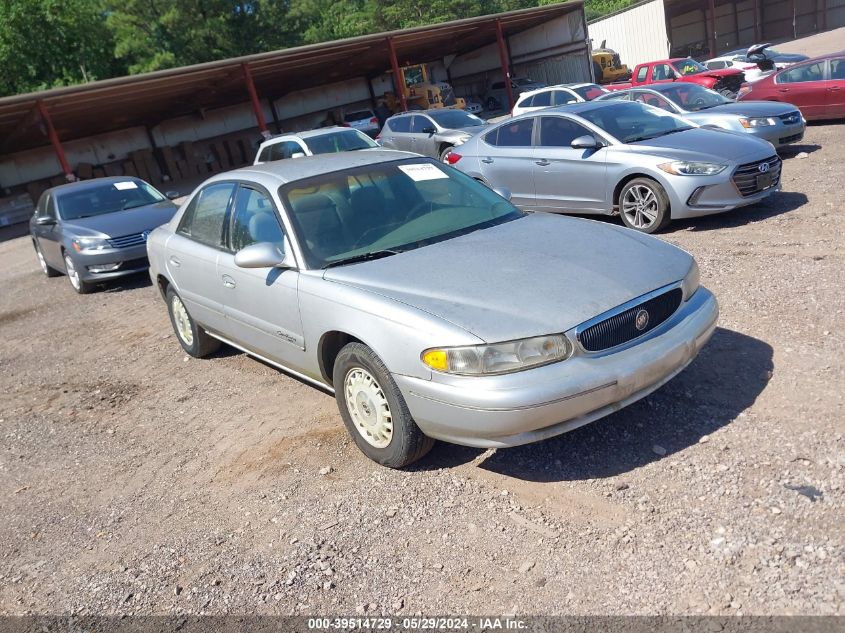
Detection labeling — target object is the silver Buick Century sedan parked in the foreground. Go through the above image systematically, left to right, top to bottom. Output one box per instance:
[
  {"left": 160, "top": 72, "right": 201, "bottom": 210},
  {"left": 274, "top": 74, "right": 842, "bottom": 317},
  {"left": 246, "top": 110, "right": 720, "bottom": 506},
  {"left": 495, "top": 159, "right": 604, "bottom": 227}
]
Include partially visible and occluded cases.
[{"left": 147, "top": 150, "right": 718, "bottom": 468}]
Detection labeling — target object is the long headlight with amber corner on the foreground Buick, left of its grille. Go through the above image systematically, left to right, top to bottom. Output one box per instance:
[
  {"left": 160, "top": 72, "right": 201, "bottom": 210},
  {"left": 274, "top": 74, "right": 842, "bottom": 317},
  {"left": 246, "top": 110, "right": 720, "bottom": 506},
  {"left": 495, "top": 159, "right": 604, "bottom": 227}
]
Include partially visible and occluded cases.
[{"left": 420, "top": 334, "right": 572, "bottom": 376}]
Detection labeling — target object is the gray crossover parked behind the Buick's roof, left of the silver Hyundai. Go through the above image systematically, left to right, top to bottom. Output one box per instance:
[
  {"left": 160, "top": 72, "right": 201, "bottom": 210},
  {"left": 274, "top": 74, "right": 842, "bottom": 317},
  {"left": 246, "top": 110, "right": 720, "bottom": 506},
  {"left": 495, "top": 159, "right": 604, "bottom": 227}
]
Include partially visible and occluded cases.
[{"left": 377, "top": 108, "right": 486, "bottom": 162}]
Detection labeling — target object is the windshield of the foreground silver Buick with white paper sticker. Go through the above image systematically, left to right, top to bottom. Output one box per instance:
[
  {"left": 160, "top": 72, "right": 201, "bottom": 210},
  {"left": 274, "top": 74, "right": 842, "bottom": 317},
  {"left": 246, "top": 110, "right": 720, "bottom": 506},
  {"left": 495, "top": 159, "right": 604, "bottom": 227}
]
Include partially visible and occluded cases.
[{"left": 279, "top": 157, "right": 522, "bottom": 268}]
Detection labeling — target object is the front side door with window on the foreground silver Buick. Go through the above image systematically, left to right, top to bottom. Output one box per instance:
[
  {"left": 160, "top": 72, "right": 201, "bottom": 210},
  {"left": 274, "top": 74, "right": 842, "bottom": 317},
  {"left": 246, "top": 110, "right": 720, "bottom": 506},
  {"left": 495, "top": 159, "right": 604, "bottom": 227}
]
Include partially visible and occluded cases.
[{"left": 217, "top": 186, "right": 306, "bottom": 371}]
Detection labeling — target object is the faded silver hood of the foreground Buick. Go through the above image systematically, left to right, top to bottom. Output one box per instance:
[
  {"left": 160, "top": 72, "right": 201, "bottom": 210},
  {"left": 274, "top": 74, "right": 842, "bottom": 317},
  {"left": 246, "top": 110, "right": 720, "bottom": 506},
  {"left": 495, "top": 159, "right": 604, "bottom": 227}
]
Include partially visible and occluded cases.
[{"left": 325, "top": 213, "right": 691, "bottom": 342}]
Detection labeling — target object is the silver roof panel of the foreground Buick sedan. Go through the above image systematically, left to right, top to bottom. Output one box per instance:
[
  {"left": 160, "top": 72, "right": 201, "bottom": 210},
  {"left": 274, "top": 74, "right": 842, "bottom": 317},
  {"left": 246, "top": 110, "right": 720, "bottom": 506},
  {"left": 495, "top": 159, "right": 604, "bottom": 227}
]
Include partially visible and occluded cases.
[{"left": 203, "top": 149, "right": 422, "bottom": 188}]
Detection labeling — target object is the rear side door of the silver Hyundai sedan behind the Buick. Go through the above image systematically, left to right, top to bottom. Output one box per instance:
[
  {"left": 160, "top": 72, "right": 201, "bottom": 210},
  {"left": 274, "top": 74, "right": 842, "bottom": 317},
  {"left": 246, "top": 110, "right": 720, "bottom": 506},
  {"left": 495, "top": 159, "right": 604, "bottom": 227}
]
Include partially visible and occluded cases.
[{"left": 478, "top": 118, "right": 536, "bottom": 209}]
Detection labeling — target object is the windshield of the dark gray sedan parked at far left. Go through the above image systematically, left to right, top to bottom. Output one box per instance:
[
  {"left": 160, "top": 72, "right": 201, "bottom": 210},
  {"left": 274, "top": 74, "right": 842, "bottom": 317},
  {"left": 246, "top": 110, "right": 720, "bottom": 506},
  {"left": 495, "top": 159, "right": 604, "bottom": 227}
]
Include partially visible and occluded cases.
[{"left": 56, "top": 180, "right": 165, "bottom": 220}]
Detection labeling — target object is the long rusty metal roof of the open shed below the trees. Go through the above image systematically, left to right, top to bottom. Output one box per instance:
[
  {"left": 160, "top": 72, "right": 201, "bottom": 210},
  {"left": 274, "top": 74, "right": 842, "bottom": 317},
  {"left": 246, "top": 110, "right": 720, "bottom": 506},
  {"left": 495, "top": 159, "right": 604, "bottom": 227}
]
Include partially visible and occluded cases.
[{"left": 0, "top": 0, "right": 583, "bottom": 154}]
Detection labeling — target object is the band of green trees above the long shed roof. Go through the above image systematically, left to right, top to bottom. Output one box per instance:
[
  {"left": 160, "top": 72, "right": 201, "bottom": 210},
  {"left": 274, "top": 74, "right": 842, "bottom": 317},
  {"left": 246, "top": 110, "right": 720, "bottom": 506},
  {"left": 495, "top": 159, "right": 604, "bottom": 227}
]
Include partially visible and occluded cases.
[{"left": 0, "top": 0, "right": 634, "bottom": 96}]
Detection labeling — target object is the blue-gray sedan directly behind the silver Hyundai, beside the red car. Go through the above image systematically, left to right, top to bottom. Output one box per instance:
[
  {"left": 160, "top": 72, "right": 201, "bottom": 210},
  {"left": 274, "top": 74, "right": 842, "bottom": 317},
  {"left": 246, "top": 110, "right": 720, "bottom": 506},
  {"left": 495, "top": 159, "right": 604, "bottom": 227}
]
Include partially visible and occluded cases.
[{"left": 598, "top": 82, "right": 807, "bottom": 147}]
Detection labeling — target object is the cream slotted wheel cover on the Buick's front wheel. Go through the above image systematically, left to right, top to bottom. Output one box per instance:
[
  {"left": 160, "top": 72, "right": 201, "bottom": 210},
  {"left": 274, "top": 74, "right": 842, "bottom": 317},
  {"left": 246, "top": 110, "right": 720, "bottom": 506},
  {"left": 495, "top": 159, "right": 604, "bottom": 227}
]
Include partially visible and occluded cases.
[{"left": 343, "top": 367, "right": 393, "bottom": 448}]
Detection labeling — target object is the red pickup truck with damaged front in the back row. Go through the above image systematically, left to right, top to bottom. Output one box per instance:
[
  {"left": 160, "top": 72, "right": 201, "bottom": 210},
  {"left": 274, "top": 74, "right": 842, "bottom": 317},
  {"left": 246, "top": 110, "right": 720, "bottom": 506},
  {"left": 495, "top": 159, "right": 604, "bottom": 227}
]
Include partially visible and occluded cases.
[{"left": 604, "top": 57, "right": 745, "bottom": 99}]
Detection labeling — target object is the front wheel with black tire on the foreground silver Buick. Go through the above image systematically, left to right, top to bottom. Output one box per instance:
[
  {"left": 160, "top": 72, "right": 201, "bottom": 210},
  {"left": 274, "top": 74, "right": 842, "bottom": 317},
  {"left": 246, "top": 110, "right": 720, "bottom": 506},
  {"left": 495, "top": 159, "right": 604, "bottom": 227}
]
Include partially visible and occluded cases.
[{"left": 332, "top": 343, "right": 434, "bottom": 468}]
